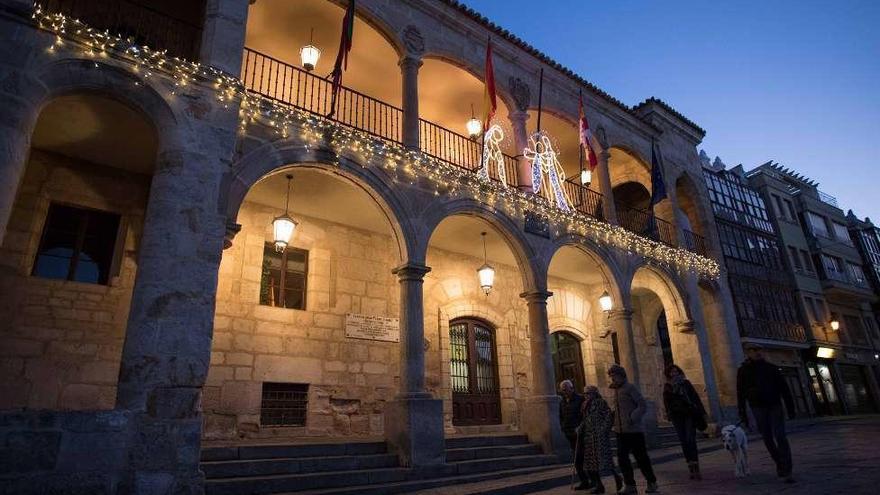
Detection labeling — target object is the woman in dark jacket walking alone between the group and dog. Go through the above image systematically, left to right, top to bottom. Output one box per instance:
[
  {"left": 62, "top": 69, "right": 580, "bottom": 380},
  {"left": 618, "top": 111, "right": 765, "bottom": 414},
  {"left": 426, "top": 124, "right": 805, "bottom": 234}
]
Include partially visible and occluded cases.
[{"left": 663, "top": 364, "right": 708, "bottom": 480}]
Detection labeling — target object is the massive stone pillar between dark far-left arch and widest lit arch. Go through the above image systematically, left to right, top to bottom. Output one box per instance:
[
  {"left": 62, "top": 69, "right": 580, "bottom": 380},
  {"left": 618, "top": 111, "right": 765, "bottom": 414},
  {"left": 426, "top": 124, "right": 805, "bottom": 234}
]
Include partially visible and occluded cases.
[{"left": 116, "top": 127, "right": 236, "bottom": 494}]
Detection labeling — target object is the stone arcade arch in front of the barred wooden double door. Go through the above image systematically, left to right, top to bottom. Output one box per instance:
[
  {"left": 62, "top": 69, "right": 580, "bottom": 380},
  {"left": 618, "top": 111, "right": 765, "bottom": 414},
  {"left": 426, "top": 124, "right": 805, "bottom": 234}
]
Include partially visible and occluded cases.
[{"left": 412, "top": 198, "right": 547, "bottom": 292}]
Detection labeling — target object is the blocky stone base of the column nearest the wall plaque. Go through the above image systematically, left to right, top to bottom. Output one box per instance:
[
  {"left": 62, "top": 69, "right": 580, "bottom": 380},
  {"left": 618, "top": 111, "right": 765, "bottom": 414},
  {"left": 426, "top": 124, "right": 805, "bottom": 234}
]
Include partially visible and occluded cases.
[{"left": 385, "top": 396, "right": 446, "bottom": 467}]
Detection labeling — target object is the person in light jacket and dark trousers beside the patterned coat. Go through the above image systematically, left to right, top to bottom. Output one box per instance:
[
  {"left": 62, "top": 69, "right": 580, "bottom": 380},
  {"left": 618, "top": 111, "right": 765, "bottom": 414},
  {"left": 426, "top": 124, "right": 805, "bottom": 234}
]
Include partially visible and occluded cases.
[{"left": 608, "top": 364, "right": 657, "bottom": 495}]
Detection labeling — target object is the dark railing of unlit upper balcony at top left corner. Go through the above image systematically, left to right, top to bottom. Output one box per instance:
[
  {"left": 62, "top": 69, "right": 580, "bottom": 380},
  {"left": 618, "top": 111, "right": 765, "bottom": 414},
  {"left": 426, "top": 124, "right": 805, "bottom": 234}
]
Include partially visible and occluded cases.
[{"left": 35, "top": 0, "right": 204, "bottom": 61}]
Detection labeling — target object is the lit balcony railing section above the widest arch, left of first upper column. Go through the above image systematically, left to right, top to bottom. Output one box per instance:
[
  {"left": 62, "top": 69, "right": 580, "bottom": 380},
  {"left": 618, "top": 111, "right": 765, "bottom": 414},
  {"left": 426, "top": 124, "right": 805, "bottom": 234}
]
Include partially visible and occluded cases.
[{"left": 241, "top": 48, "right": 403, "bottom": 143}]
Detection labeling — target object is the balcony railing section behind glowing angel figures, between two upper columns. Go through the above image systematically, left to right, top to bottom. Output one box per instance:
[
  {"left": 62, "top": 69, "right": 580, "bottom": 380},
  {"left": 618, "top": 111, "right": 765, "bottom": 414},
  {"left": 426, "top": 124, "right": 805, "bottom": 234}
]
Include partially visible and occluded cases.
[{"left": 419, "top": 119, "right": 517, "bottom": 187}]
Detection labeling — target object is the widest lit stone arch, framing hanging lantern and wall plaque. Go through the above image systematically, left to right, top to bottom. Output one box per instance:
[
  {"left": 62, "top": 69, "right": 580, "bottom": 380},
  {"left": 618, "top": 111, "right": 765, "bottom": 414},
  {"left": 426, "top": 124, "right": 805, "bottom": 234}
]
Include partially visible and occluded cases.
[{"left": 218, "top": 140, "right": 412, "bottom": 261}]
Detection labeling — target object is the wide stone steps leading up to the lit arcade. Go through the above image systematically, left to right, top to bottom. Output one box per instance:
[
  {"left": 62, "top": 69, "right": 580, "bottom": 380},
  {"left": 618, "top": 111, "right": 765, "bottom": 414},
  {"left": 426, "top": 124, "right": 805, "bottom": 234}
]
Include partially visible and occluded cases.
[{"left": 202, "top": 434, "right": 559, "bottom": 495}]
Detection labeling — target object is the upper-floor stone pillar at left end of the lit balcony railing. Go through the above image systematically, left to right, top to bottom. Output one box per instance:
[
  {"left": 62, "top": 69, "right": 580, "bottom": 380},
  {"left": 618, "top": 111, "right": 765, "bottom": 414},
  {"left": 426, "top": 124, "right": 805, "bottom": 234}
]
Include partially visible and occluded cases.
[{"left": 199, "top": 0, "right": 249, "bottom": 77}]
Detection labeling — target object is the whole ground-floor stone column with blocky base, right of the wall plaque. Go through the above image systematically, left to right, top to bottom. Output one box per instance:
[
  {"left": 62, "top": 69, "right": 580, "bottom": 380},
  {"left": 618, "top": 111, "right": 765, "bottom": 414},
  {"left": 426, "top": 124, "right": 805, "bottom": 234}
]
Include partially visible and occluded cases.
[{"left": 385, "top": 262, "right": 446, "bottom": 466}]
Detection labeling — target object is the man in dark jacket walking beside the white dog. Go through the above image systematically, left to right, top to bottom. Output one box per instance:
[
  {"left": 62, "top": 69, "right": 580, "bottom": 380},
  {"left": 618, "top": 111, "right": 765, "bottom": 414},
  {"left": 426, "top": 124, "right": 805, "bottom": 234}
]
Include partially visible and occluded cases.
[{"left": 736, "top": 344, "right": 794, "bottom": 483}]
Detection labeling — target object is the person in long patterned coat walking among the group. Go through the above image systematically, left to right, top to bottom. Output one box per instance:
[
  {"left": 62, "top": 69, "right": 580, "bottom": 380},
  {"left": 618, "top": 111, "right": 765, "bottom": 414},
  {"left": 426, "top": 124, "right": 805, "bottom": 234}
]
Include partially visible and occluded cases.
[{"left": 578, "top": 386, "right": 623, "bottom": 493}]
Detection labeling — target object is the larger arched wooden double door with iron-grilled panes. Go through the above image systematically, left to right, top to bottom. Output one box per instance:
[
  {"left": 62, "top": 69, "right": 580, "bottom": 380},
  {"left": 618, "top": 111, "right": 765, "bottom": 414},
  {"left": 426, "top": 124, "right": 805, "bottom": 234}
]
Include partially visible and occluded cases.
[{"left": 449, "top": 319, "right": 501, "bottom": 426}]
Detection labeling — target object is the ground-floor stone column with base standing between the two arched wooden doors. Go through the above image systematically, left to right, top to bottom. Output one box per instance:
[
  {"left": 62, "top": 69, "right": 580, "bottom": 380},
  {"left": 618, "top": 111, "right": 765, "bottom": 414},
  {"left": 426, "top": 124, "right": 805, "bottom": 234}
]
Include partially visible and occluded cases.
[{"left": 520, "top": 290, "right": 571, "bottom": 458}]
